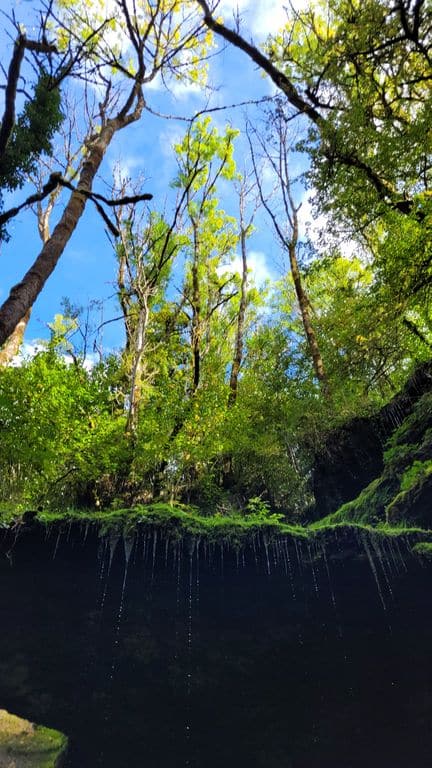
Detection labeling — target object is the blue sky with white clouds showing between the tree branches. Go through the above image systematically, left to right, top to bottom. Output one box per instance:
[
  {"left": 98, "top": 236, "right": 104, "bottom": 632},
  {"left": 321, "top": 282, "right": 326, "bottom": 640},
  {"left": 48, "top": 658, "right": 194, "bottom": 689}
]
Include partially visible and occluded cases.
[{"left": 0, "top": 0, "right": 316, "bottom": 350}]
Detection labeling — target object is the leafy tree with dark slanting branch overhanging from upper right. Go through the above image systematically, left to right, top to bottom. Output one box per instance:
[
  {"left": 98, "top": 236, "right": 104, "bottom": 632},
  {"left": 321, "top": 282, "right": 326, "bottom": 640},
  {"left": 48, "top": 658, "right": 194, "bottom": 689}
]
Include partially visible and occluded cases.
[{"left": 198, "top": 0, "right": 432, "bottom": 380}]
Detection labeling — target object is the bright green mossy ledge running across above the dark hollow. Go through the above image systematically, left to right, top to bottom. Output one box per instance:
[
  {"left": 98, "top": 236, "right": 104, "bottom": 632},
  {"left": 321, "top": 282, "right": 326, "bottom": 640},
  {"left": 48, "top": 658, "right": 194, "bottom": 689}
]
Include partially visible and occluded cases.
[{"left": 0, "top": 381, "right": 432, "bottom": 556}]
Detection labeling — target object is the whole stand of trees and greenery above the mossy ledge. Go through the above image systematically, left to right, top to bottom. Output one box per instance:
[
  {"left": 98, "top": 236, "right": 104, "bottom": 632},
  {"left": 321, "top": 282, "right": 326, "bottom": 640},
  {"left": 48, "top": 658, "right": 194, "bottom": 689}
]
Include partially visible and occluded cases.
[{"left": 0, "top": 0, "right": 432, "bottom": 517}]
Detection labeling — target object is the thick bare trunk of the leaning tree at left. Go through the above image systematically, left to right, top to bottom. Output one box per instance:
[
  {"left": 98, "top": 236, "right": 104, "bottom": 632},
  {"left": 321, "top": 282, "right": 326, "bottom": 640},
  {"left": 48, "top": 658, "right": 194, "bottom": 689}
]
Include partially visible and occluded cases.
[{"left": 0, "top": 90, "right": 144, "bottom": 345}]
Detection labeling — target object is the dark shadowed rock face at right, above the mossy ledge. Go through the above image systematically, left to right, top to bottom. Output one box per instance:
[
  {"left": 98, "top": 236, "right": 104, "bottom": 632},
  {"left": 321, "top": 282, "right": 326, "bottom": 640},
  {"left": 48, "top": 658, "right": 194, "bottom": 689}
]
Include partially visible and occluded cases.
[{"left": 312, "top": 363, "right": 432, "bottom": 522}]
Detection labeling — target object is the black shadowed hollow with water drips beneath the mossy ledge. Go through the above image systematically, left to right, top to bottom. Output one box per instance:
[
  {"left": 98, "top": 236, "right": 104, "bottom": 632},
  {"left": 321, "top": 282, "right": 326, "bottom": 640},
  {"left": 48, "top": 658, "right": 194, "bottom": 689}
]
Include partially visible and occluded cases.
[{"left": 0, "top": 530, "right": 432, "bottom": 768}]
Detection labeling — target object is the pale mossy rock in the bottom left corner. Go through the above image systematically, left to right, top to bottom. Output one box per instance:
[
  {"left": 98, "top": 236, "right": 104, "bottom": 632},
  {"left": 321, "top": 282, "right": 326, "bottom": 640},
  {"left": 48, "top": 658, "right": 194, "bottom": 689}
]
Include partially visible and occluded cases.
[{"left": 0, "top": 709, "right": 67, "bottom": 768}]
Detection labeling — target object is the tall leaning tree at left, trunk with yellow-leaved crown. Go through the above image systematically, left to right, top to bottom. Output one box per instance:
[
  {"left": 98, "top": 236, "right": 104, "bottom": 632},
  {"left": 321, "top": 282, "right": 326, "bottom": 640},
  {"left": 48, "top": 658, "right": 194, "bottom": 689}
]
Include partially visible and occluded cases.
[{"left": 0, "top": 0, "right": 215, "bottom": 344}]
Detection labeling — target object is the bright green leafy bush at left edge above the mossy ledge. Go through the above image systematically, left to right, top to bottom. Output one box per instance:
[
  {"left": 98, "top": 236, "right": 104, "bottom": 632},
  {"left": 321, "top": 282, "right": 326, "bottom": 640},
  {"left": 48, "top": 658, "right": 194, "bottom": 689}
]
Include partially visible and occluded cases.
[{"left": 0, "top": 351, "right": 127, "bottom": 507}]
